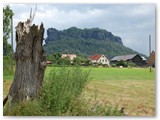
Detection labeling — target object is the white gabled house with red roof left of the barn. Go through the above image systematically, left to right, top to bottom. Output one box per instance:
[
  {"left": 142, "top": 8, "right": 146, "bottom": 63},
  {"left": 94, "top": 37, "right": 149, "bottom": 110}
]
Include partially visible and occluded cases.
[{"left": 89, "top": 54, "right": 109, "bottom": 66}]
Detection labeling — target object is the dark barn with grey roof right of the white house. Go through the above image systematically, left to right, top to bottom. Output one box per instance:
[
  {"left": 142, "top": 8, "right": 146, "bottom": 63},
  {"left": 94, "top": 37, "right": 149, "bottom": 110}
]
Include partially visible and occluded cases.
[{"left": 110, "top": 54, "right": 146, "bottom": 66}]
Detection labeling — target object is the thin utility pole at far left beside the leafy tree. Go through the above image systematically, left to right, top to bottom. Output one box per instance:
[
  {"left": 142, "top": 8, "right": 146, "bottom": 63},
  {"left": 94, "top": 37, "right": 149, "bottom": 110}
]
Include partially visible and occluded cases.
[{"left": 11, "top": 16, "right": 13, "bottom": 71}]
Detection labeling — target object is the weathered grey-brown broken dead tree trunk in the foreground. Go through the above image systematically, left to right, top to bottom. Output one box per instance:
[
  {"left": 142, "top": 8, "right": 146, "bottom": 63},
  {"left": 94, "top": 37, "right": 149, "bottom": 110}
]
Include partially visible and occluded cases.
[{"left": 8, "top": 22, "right": 46, "bottom": 105}]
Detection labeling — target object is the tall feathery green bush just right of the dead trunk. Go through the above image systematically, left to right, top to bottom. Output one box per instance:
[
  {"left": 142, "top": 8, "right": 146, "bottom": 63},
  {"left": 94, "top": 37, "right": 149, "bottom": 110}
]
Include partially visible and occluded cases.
[{"left": 41, "top": 68, "right": 89, "bottom": 115}]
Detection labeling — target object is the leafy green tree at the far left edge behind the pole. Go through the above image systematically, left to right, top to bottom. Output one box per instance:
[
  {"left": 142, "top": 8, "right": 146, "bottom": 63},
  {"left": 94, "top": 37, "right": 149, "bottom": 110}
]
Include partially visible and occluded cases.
[{"left": 3, "top": 5, "right": 14, "bottom": 55}]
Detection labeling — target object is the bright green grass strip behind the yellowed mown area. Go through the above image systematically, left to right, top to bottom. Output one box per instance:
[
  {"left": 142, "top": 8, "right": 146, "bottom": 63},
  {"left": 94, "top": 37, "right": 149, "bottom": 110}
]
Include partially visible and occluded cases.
[{"left": 45, "top": 67, "right": 155, "bottom": 80}]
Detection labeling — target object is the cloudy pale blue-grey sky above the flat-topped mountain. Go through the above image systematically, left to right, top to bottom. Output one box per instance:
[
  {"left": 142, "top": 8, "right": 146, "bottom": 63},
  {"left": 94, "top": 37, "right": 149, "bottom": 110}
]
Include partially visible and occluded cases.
[{"left": 6, "top": 4, "right": 156, "bottom": 56}]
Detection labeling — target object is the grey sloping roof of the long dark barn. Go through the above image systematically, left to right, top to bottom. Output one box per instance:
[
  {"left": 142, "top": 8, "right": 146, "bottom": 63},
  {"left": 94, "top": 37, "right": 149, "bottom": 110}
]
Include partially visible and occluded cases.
[{"left": 111, "top": 54, "right": 137, "bottom": 61}]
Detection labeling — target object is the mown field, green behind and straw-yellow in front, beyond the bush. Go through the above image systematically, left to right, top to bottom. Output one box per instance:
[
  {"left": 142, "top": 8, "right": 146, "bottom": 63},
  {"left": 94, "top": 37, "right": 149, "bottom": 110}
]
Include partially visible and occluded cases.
[{"left": 3, "top": 67, "right": 155, "bottom": 116}]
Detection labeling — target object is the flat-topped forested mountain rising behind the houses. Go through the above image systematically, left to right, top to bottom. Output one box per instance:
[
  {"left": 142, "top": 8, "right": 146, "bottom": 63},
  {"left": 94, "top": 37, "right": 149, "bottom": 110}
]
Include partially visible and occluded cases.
[{"left": 44, "top": 27, "right": 137, "bottom": 59}]
